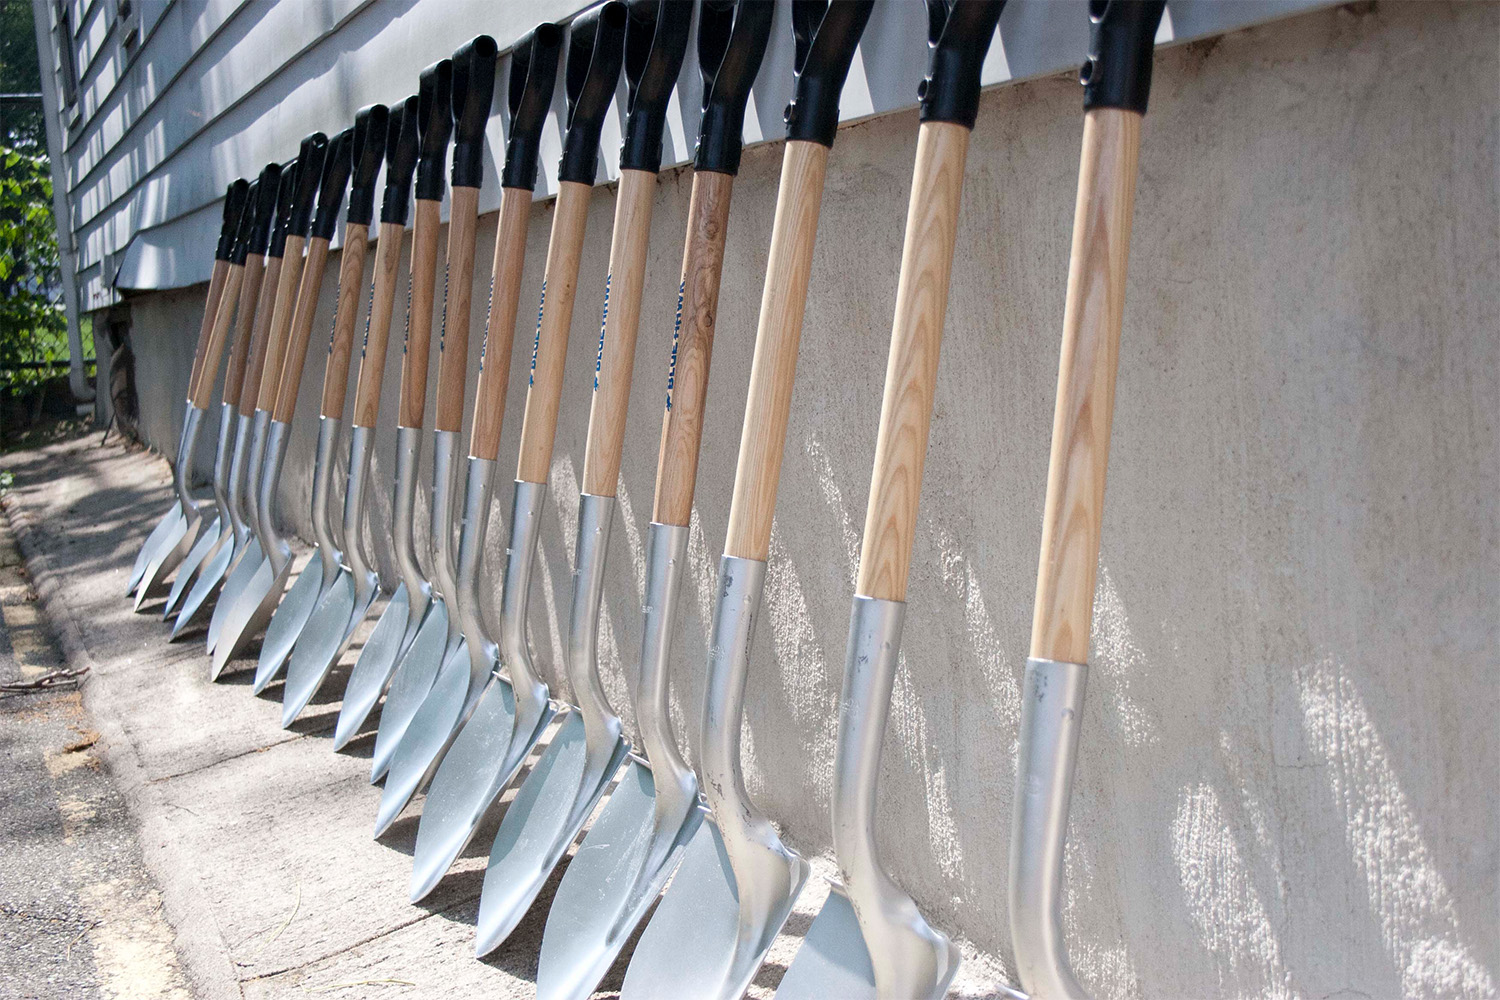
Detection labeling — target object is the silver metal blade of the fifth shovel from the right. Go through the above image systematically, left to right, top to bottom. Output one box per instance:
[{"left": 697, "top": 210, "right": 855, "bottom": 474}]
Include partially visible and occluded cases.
[{"left": 474, "top": 712, "right": 627, "bottom": 958}]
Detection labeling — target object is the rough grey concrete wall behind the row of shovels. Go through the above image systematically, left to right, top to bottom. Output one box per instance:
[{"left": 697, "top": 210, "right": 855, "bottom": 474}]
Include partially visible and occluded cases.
[{"left": 123, "top": 3, "right": 1500, "bottom": 999}]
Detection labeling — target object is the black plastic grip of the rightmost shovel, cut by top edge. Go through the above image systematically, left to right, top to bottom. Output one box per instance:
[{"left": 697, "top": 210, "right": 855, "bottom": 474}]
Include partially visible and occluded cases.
[{"left": 1079, "top": 0, "right": 1167, "bottom": 114}]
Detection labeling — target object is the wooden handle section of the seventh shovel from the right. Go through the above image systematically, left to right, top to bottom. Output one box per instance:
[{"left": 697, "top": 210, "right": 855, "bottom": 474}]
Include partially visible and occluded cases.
[{"left": 470, "top": 187, "right": 531, "bottom": 462}]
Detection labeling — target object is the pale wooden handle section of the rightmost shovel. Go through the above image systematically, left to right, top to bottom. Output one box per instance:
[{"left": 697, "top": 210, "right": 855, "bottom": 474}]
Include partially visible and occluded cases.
[{"left": 1031, "top": 108, "right": 1142, "bottom": 663}]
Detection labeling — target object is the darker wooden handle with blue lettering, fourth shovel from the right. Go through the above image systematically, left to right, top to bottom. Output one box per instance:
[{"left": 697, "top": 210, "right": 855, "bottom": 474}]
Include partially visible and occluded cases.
[{"left": 651, "top": 171, "right": 735, "bottom": 526}]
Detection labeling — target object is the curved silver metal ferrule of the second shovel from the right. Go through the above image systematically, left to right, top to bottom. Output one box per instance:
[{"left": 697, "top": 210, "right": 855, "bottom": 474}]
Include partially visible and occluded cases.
[{"left": 833, "top": 597, "right": 959, "bottom": 997}]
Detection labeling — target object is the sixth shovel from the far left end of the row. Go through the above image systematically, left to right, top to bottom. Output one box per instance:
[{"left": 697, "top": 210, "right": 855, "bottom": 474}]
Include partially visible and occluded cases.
[{"left": 210, "top": 129, "right": 353, "bottom": 679}]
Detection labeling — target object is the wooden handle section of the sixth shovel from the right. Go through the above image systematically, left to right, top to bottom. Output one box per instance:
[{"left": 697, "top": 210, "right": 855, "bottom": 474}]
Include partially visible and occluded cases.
[{"left": 516, "top": 180, "right": 593, "bottom": 483}]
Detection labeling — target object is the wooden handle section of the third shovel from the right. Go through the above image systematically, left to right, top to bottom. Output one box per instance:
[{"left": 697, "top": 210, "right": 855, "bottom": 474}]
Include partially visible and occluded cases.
[{"left": 725, "top": 142, "right": 828, "bottom": 561}]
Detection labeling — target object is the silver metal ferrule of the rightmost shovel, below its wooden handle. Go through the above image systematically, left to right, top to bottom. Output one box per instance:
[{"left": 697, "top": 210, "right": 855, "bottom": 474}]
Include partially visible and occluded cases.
[{"left": 1010, "top": 658, "right": 1089, "bottom": 1000}]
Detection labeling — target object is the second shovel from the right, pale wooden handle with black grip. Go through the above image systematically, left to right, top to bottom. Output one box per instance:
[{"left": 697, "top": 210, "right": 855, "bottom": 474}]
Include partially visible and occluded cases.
[{"left": 777, "top": 7, "right": 1005, "bottom": 1000}]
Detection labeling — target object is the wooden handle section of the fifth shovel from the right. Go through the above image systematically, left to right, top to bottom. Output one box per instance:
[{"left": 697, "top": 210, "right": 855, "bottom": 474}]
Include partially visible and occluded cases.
[{"left": 584, "top": 169, "right": 656, "bottom": 496}]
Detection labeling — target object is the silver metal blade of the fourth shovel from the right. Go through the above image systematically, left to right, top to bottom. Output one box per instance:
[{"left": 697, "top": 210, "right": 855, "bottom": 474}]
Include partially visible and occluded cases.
[{"left": 537, "top": 760, "right": 704, "bottom": 1000}]
